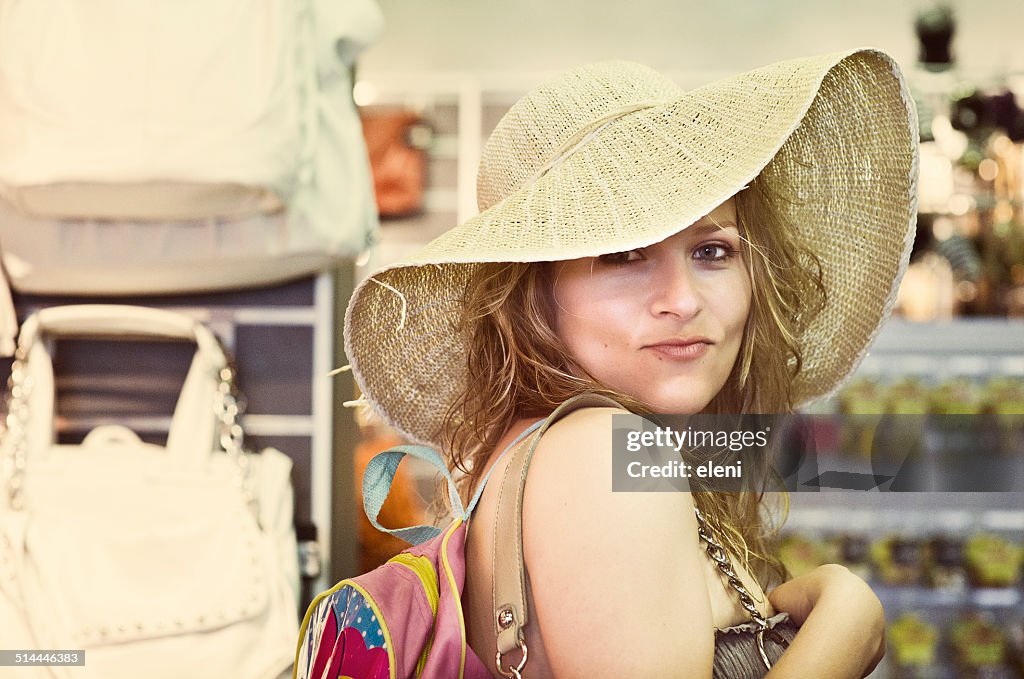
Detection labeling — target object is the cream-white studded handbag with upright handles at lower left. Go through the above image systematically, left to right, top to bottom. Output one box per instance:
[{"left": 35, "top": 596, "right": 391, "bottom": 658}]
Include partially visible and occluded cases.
[{"left": 0, "top": 305, "right": 298, "bottom": 679}]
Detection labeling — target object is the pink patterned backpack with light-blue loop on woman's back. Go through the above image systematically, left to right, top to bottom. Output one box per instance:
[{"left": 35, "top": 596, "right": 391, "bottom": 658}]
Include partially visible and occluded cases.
[{"left": 295, "top": 395, "right": 617, "bottom": 679}]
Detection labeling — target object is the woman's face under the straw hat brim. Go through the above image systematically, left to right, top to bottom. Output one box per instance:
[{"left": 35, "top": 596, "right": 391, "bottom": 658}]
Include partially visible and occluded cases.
[{"left": 553, "top": 199, "right": 751, "bottom": 414}]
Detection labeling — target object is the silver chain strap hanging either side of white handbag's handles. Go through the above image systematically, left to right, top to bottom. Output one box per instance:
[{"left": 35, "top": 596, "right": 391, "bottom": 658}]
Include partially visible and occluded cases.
[{"left": 4, "top": 346, "right": 262, "bottom": 528}]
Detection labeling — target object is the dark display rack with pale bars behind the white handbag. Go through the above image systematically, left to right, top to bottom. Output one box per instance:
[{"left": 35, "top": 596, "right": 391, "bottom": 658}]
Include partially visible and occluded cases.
[{"left": 2, "top": 270, "right": 358, "bottom": 609}]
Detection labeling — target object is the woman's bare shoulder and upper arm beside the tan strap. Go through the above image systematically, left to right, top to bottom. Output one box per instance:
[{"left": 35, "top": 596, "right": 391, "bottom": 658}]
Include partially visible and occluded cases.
[{"left": 523, "top": 408, "right": 714, "bottom": 677}]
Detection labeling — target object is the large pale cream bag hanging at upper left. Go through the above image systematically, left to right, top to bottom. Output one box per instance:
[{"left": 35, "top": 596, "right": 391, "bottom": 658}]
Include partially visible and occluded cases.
[{"left": 0, "top": 0, "right": 381, "bottom": 352}]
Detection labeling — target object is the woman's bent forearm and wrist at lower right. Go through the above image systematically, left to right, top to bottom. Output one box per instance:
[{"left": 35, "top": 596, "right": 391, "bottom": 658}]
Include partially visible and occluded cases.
[{"left": 768, "top": 563, "right": 886, "bottom": 677}]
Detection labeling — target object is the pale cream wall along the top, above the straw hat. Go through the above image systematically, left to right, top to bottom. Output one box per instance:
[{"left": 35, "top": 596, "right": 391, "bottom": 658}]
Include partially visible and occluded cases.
[{"left": 360, "top": 0, "right": 1024, "bottom": 80}]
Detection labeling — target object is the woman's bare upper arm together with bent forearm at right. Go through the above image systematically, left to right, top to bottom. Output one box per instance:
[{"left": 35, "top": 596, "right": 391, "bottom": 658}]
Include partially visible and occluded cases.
[{"left": 523, "top": 409, "right": 885, "bottom": 679}]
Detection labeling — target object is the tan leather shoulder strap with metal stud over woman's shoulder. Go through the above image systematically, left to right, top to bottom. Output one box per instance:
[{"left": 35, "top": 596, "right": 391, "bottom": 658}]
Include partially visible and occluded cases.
[{"left": 492, "top": 393, "right": 622, "bottom": 676}]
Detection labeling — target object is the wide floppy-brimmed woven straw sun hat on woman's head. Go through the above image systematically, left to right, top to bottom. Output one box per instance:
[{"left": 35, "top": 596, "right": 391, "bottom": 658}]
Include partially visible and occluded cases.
[{"left": 345, "top": 50, "right": 918, "bottom": 448}]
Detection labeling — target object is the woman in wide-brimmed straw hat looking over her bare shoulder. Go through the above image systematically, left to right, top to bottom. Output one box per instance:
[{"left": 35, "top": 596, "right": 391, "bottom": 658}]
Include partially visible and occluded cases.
[{"left": 346, "top": 50, "right": 916, "bottom": 677}]
